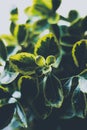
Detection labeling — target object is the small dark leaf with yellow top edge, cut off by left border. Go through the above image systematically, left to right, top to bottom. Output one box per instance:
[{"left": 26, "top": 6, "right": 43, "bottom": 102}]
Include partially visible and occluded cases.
[{"left": 0, "top": 86, "right": 10, "bottom": 99}]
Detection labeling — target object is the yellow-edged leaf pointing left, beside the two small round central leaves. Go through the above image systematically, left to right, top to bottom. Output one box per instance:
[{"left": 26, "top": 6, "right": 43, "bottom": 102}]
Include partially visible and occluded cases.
[{"left": 9, "top": 52, "right": 37, "bottom": 75}]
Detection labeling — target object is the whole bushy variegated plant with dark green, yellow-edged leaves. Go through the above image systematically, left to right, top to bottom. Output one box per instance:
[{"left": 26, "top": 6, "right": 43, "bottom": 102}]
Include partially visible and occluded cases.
[{"left": 0, "top": 0, "right": 87, "bottom": 130}]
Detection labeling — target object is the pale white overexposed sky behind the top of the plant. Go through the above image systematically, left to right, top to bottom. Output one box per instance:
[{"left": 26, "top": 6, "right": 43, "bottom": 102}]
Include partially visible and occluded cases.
[{"left": 0, "top": 0, "right": 87, "bottom": 35}]
